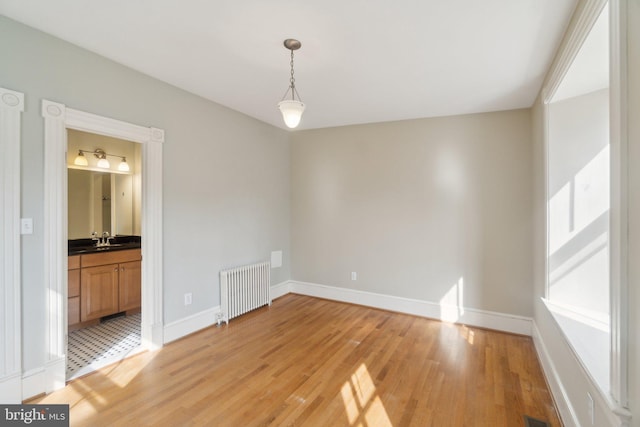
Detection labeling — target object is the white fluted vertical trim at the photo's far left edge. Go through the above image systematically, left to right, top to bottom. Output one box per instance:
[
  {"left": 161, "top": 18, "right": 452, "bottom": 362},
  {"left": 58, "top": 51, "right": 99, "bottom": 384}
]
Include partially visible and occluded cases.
[{"left": 0, "top": 88, "right": 24, "bottom": 403}]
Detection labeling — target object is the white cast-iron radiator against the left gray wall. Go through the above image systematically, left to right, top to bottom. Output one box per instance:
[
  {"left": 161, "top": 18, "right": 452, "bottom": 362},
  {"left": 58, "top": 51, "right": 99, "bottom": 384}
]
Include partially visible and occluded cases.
[{"left": 220, "top": 262, "right": 271, "bottom": 323}]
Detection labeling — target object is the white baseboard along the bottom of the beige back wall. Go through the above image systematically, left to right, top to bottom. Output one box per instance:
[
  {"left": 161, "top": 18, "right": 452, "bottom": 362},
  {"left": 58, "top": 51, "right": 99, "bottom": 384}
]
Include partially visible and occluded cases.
[{"left": 289, "top": 280, "right": 532, "bottom": 336}]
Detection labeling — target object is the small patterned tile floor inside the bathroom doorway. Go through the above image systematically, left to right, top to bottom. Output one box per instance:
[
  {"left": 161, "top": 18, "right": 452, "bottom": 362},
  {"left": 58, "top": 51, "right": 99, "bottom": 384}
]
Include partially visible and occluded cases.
[{"left": 67, "top": 313, "right": 142, "bottom": 380}]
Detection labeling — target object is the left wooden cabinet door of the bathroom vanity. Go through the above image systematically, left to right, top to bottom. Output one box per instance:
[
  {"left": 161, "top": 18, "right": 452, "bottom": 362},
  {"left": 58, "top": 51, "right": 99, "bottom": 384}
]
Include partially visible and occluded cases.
[{"left": 80, "top": 264, "right": 118, "bottom": 322}]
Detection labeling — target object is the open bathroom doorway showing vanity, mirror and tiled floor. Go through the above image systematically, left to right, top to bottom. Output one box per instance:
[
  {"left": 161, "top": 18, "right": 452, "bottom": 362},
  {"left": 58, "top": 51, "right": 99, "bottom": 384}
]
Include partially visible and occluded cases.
[{"left": 66, "top": 129, "right": 142, "bottom": 381}]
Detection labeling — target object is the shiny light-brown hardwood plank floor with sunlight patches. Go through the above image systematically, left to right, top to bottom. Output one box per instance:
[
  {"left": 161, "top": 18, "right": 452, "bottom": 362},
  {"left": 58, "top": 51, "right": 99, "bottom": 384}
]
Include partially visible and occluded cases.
[{"left": 29, "top": 294, "right": 561, "bottom": 427}]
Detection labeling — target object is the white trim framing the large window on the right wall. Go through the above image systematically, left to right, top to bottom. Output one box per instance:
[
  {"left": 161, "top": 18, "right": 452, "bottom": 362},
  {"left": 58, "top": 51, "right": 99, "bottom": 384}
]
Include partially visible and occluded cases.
[{"left": 542, "top": 0, "right": 628, "bottom": 417}]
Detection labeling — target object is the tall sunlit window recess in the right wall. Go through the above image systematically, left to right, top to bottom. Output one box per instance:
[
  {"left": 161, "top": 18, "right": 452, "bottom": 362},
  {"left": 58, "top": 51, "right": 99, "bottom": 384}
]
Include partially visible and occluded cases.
[{"left": 547, "top": 6, "right": 611, "bottom": 393}]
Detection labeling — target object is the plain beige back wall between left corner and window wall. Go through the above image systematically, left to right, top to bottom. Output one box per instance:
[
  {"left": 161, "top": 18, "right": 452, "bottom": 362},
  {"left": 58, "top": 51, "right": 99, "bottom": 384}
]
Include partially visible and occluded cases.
[{"left": 291, "top": 110, "right": 532, "bottom": 316}]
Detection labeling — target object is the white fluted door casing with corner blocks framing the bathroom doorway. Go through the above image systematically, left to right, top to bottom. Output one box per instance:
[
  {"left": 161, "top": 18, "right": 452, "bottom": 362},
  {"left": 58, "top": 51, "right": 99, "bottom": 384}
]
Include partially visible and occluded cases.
[{"left": 39, "top": 100, "right": 164, "bottom": 393}]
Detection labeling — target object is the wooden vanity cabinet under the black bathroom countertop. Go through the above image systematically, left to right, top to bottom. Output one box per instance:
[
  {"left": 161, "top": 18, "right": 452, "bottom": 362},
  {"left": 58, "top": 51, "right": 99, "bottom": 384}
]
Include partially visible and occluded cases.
[{"left": 69, "top": 249, "right": 142, "bottom": 325}]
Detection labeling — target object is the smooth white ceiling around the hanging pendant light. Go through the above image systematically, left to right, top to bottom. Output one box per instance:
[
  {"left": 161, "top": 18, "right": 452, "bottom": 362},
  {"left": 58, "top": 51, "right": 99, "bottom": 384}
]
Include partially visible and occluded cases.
[{"left": 0, "top": 0, "right": 576, "bottom": 129}]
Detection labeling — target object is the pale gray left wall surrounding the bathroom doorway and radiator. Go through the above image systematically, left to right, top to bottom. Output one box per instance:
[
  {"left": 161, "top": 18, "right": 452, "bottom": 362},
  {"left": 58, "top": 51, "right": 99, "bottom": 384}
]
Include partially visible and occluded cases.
[{"left": 0, "top": 16, "right": 290, "bottom": 370}]
